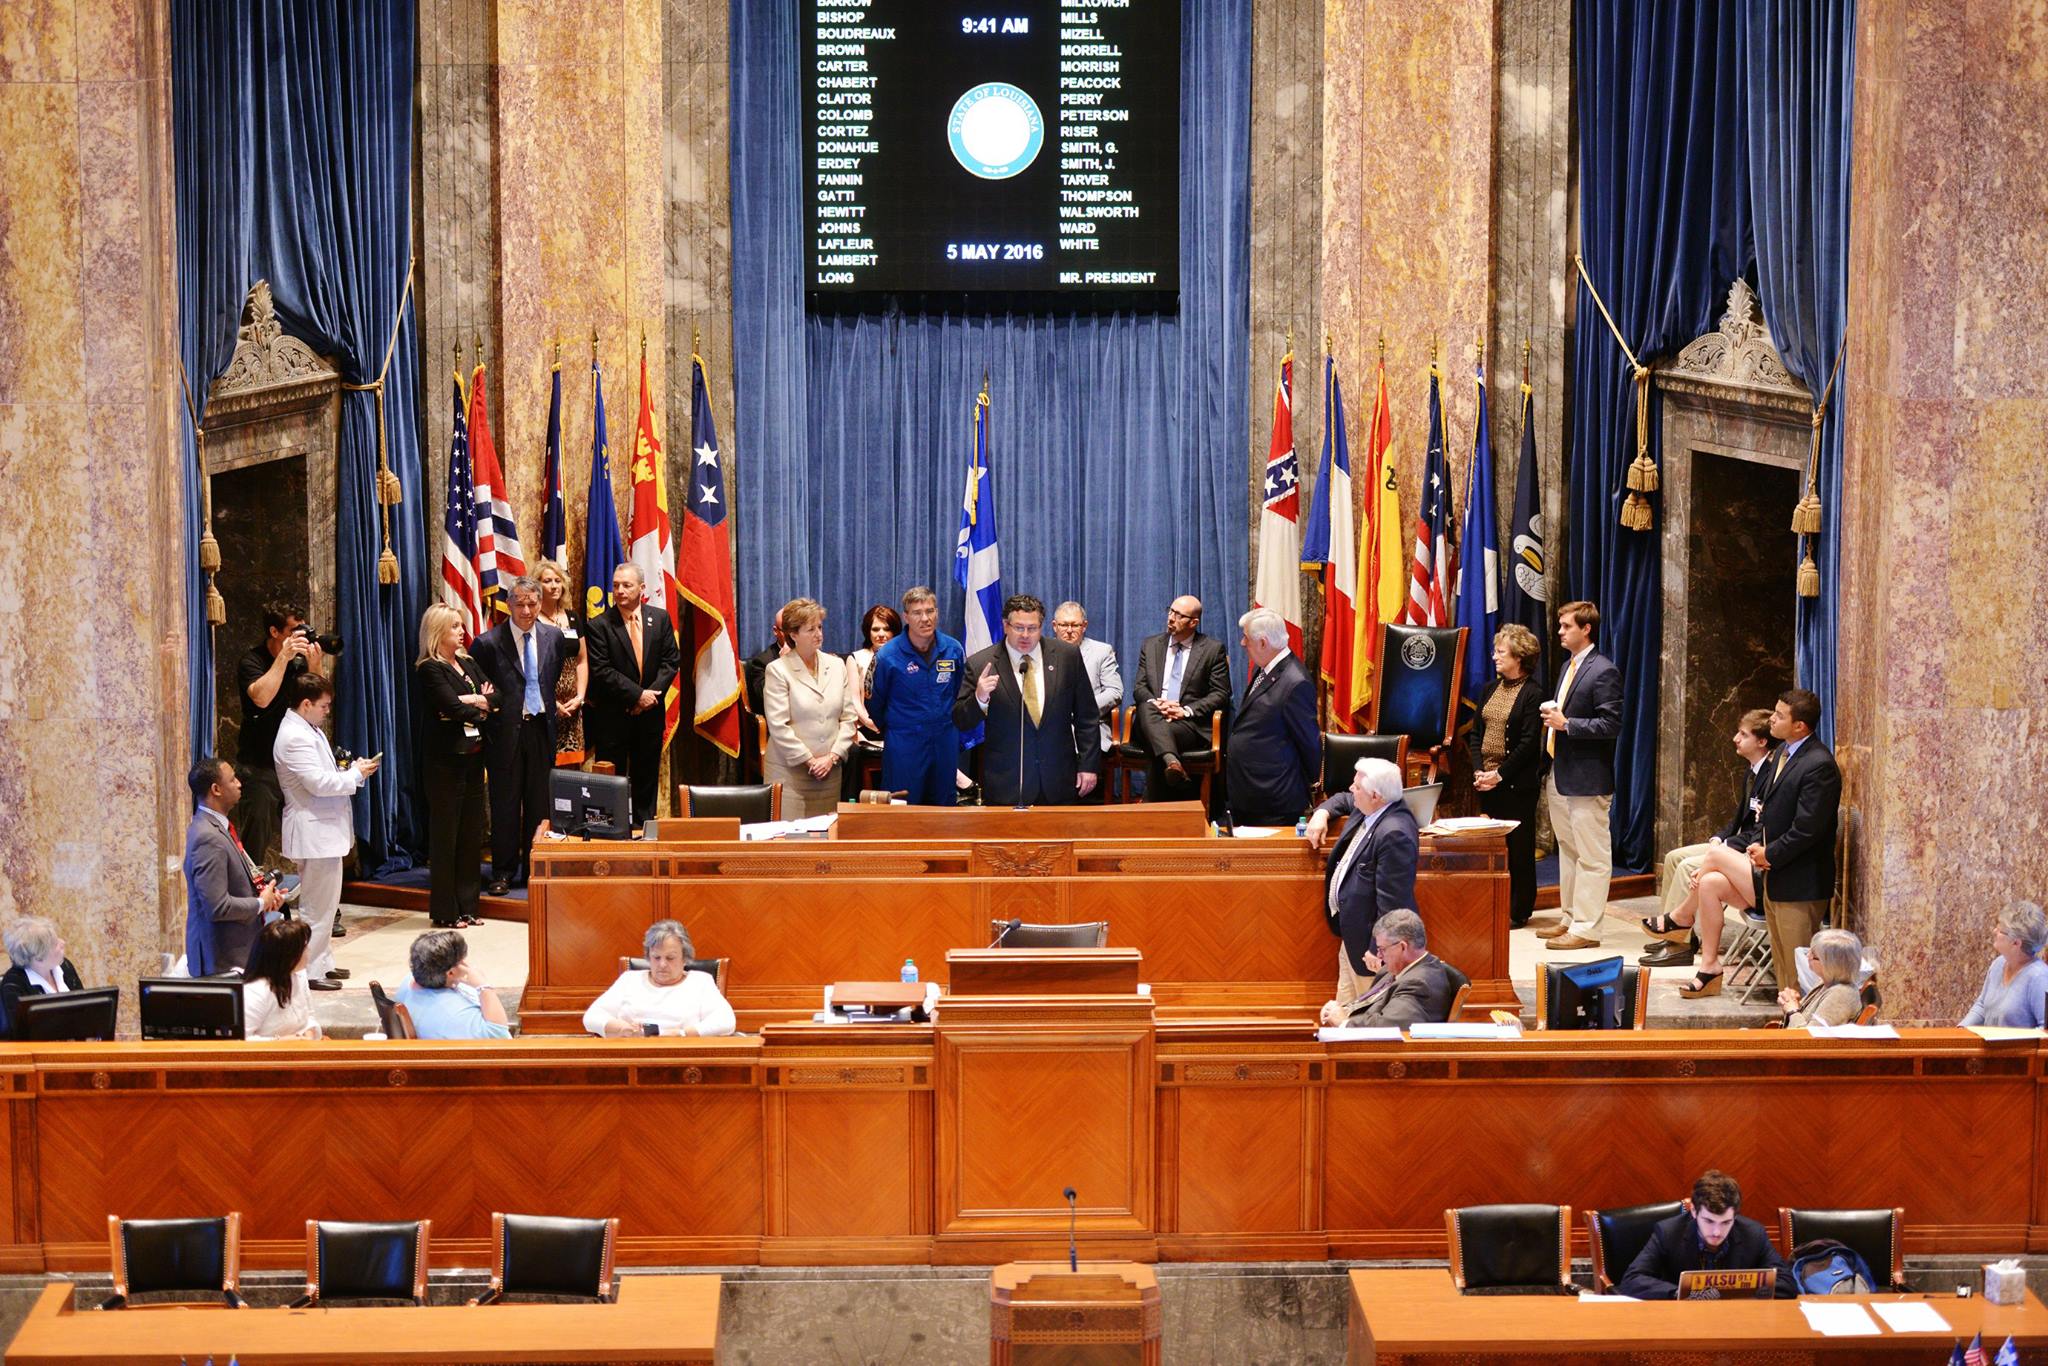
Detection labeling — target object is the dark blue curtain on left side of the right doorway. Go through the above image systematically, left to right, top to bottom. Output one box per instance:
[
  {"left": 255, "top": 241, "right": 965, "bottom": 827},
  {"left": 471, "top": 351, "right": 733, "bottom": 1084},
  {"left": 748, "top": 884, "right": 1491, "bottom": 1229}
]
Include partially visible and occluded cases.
[{"left": 1565, "top": 0, "right": 1753, "bottom": 868}]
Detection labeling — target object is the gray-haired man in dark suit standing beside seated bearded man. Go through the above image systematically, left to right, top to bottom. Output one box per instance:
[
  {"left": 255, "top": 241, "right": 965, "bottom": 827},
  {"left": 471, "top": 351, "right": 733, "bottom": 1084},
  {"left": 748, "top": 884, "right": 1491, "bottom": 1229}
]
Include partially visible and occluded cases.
[{"left": 1223, "top": 606, "right": 1323, "bottom": 825}]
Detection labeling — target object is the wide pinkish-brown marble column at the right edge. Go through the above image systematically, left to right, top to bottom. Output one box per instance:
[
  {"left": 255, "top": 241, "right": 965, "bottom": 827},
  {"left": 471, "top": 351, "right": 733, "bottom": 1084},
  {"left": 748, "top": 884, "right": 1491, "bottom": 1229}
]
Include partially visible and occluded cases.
[{"left": 1825, "top": 0, "right": 2048, "bottom": 1022}]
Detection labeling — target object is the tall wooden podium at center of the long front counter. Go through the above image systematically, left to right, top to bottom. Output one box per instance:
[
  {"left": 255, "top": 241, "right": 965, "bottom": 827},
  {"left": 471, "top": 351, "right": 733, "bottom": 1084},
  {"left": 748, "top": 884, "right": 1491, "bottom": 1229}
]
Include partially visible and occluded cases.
[{"left": 932, "top": 948, "right": 1159, "bottom": 1264}]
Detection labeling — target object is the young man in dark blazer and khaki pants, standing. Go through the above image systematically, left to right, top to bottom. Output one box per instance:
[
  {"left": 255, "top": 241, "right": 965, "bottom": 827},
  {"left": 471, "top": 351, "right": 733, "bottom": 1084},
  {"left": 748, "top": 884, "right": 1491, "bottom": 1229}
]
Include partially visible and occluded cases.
[{"left": 1536, "top": 602, "right": 1622, "bottom": 950}]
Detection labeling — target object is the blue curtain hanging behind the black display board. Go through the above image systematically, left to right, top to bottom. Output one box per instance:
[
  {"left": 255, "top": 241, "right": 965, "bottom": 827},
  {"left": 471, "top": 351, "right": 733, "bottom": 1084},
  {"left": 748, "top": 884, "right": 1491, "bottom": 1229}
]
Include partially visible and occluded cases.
[{"left": 731, "top": 0, "right": 1251, "bottom": 680}]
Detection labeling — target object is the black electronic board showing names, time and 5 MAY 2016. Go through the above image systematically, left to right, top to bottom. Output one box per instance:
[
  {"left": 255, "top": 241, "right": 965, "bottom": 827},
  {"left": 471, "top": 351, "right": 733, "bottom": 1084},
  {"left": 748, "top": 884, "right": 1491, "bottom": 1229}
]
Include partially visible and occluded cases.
[{"left": 801, "top": 0, "right": 1180, "bottom": 307}]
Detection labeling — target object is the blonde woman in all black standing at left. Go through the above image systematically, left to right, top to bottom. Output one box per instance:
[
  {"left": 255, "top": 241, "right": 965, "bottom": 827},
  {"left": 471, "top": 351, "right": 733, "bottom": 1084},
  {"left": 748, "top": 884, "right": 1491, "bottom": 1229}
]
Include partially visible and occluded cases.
[{"left": 414, "top": 602, "right": 498, "bottom": 930}]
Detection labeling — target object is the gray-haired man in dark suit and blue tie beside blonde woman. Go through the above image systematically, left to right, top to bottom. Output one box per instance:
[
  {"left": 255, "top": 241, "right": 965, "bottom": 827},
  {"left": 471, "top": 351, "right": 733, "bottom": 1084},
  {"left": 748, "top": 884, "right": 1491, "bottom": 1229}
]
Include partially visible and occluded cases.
[{"left": 471, "top": 575, "right": 569, "bottom": 897}]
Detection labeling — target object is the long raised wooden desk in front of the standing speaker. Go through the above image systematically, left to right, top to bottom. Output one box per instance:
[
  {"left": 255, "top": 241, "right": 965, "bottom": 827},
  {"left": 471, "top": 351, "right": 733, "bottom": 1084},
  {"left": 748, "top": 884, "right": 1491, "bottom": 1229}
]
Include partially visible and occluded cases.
[{"left": 520, "top": 827, "right": 1507, "bottom": 1034}]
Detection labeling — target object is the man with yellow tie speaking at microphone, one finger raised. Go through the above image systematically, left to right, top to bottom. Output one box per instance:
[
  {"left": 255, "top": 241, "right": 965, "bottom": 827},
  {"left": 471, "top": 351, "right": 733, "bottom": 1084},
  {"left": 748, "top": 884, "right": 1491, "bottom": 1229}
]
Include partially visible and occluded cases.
[{"left": 952, "top": 594, "right": 1102, "bottom": 807}]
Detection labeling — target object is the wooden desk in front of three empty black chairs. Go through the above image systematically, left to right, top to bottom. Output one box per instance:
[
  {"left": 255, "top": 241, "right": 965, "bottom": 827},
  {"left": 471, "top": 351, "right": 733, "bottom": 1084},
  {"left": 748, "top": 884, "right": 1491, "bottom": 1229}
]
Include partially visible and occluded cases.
[{"left": 6, "top": 1276, "right": 719, "bottom": 1366}]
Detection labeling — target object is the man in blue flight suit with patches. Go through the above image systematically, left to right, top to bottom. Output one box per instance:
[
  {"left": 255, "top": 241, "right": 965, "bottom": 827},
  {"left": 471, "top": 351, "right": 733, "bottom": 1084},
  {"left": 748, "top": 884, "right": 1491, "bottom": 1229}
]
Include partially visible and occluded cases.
[{"left": 868, "top": 586, "right": 967, "bottom": 807}]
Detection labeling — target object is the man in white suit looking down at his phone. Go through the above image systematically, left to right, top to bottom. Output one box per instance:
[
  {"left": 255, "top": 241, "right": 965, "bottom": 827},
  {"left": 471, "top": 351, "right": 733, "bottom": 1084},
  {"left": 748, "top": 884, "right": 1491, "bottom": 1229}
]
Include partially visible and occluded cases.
[{"left": 272, "top": 670, "right": 381, "bottom": 991}]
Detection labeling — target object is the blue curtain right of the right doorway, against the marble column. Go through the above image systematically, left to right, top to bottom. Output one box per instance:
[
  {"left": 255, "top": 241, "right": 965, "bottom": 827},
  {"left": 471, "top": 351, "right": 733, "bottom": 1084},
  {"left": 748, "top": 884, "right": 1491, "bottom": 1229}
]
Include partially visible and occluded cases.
[{"left": 1735, "top": 0, "right": 1855, "bottom": 743}]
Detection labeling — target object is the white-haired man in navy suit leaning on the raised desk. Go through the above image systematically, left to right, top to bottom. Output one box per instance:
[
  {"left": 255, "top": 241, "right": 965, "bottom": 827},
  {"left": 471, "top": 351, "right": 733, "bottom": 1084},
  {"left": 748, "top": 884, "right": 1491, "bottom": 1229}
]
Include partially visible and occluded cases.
[{"left": 1305, "top": 760, "right": 1421, "bottom": 1024}]
